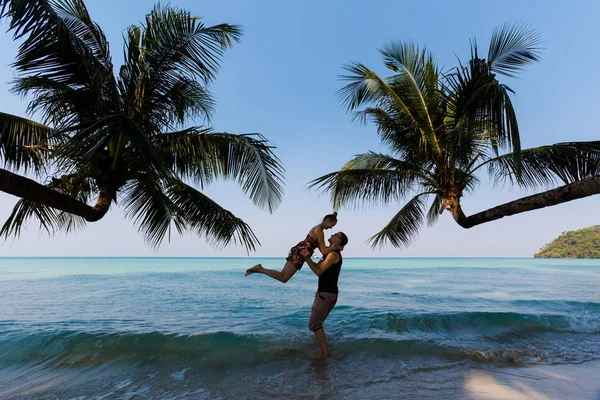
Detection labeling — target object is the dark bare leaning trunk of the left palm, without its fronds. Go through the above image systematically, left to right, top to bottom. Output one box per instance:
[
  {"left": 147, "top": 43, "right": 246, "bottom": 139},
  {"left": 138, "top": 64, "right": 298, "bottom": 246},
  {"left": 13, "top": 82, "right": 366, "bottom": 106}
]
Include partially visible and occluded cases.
[{"left": 0, "top": 168, "right": 114, "bottom": 222}]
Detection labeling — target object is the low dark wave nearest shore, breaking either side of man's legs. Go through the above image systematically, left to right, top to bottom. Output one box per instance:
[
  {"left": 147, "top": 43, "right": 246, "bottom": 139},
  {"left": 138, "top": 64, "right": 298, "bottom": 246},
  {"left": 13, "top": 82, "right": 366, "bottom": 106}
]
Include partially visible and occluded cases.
[{"left": 0, "top": 332, "right": 600, "bottom": 369}]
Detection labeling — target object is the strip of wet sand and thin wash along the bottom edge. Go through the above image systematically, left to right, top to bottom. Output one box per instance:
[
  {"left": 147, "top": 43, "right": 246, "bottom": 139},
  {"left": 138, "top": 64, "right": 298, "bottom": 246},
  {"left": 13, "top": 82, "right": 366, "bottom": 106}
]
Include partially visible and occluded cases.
[{"left": 0, "top": 359, "right": 600, "bottom": 400}]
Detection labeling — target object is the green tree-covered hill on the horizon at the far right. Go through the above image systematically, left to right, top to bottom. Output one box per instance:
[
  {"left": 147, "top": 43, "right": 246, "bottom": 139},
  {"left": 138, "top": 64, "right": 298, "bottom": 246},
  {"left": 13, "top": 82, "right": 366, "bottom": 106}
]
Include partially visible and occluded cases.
[{"left": 534, "top": 225, "right": 600, "bottom": 258}]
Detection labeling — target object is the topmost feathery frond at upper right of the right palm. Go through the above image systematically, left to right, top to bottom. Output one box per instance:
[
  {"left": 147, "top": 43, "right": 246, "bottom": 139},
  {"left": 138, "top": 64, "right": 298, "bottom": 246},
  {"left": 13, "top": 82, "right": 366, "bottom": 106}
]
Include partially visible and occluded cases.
[{"left": 487, "top": 23, "right": 542, "bottom": 77}]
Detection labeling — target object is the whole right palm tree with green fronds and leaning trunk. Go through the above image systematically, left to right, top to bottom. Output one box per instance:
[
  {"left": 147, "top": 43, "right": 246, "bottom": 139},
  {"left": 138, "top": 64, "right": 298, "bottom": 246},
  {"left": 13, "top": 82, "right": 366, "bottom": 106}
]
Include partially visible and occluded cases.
[{"left": 310, "top": 24, "right": 600, "bottom": 247}]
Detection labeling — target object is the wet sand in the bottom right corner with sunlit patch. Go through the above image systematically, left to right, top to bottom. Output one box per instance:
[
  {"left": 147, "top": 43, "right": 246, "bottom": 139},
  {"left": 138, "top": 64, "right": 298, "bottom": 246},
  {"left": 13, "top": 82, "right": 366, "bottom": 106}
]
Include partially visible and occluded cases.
[{"left": 332, "top": 360, "right": 600, "bottom": 400}]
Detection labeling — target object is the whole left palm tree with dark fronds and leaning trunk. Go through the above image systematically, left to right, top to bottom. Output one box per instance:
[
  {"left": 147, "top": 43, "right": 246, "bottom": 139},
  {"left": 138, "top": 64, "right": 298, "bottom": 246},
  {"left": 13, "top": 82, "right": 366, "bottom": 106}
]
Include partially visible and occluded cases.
[{"left": 0, "top": 0, "right": 283, "bottom": 250}]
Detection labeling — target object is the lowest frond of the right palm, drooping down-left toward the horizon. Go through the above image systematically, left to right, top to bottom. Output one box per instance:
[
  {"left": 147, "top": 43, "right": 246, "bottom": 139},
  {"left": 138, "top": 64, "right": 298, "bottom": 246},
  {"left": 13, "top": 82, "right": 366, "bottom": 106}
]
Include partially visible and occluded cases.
[{"left": 367, "top": 193, "right": 429, "bottom": 248}]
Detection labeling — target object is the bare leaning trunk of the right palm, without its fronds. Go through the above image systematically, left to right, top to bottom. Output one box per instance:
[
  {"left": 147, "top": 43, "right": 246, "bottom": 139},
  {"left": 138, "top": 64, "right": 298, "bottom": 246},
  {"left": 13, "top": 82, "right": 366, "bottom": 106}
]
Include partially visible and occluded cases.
[{"left": 450, "top": 176, "right": 600, "bottom": 229}]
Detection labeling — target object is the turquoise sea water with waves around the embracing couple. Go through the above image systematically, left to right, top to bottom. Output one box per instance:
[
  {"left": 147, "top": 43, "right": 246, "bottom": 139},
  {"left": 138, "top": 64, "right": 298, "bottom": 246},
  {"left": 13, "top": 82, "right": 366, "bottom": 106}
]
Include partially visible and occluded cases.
[{"left": 0, "top": 258, "right": 600, "bottom": 399}]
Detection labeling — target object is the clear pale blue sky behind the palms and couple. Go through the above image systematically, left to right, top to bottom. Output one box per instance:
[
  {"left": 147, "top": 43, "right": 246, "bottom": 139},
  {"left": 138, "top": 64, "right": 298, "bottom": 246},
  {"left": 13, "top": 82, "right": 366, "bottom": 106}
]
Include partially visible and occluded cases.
[{"left": 0, "top": 0, "right": 600, "bottom": 257}]
